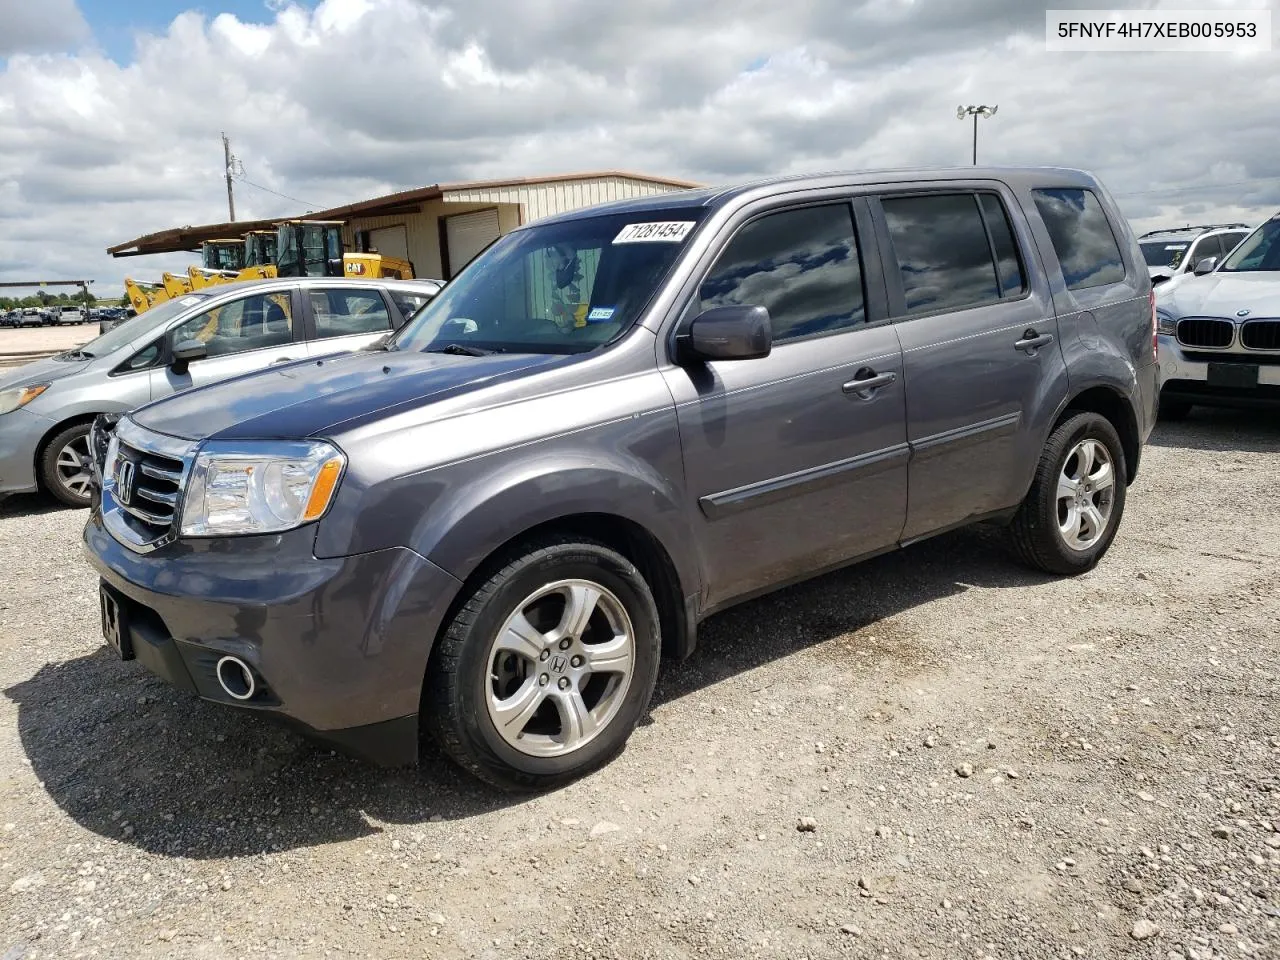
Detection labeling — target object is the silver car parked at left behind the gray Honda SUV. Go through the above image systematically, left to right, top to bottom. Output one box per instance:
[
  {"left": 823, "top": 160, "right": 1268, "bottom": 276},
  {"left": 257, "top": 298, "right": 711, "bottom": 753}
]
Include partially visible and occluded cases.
[{"left": 0, "top": 278, "right": 443, "bottom": 507}]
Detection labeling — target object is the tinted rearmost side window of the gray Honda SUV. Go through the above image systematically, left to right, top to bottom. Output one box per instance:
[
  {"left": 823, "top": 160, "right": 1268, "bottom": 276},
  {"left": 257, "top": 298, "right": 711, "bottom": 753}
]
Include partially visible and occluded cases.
[{"left": 1032, "top": 187, "right": 1124, "bottom": 291}]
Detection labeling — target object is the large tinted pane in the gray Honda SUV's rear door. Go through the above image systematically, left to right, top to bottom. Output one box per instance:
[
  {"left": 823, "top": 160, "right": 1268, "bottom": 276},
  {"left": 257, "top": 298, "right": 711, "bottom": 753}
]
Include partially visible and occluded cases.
[{"left": 881, "top": 193, "right": 1007, "bottom": 314}]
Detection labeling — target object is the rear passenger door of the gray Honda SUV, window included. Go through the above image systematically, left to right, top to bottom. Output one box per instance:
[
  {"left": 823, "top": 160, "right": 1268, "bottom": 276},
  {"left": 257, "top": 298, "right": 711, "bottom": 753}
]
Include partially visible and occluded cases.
[{"left": 874, "top": 184, "right": 1068, "bottom": 540}]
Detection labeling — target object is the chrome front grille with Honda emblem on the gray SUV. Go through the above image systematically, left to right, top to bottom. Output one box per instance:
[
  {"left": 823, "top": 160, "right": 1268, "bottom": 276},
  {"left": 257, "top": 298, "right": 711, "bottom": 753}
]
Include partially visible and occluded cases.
[{"left": 102, "top": 419, "right": 195, "bottom": 552}]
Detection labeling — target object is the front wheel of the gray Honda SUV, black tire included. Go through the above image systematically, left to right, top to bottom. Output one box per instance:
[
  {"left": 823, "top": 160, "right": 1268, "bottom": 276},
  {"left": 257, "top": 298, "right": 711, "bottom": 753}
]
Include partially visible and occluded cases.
[{"left": 422, "top": 536, "right": 662, "bottom": 791}]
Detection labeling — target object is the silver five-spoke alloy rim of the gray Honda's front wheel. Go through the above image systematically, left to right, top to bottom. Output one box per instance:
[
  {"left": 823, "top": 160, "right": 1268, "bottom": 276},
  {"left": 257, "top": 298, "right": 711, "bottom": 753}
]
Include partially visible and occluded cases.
[{"left": 485, "top": 580, "right": 635, "bottom": 756}]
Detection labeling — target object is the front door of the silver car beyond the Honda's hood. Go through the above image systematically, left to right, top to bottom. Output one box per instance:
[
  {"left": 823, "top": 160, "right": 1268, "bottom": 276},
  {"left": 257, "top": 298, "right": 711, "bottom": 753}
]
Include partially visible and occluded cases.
[{"left": 150, "top": 288, "right": 306, "bottom": 399}]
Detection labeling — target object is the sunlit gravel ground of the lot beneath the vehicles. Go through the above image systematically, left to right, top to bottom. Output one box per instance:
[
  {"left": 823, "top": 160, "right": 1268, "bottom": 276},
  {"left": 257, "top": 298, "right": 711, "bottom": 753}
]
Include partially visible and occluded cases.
[{"left": 0, "top": 412, "right": 1280, "bottom": 960}]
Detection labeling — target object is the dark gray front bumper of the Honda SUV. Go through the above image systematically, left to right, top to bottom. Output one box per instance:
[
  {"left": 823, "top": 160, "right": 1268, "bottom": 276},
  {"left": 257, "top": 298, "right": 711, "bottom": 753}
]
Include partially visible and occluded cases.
[{"left": 83, "top": 509, "right": 461, "bottom": 765}]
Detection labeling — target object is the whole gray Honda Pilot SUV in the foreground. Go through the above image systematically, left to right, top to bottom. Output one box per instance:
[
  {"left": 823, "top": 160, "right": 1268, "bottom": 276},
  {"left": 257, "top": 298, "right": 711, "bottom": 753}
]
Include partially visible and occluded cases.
[{"left": 84, "top": 169, "right": 1157, "bottom": 788}]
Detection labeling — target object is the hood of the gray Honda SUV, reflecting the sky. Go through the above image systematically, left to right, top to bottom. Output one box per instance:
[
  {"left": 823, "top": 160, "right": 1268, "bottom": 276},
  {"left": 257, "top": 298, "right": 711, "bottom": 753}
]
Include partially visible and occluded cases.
[{"left": 131, "top": 351, "right": 576, "bottom": 440}]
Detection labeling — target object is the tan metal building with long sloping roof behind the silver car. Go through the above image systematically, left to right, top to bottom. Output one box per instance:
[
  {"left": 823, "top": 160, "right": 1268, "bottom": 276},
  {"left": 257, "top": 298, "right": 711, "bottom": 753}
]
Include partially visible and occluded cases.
[{"left": 106, "top": 170, "right": 700, "bottom": 280}]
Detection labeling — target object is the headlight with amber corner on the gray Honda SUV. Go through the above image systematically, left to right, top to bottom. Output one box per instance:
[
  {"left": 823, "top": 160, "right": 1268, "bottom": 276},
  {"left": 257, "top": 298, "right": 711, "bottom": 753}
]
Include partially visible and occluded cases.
[{"left": 182, "top": 442, "right": 347, "bottom": 536}]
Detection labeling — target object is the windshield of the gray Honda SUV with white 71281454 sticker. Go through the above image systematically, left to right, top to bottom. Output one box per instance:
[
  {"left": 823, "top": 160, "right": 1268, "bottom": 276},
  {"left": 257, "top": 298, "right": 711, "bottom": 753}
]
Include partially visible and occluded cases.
[{"left": 390, "top": 207, "right": 705, "bottom": 353}]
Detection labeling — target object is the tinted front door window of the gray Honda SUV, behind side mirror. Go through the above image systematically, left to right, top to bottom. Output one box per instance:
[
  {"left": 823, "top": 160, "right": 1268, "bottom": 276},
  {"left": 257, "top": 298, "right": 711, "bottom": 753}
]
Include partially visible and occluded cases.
[{"left": 698, "top": 204, "right": 867, "bottom": 340}]
